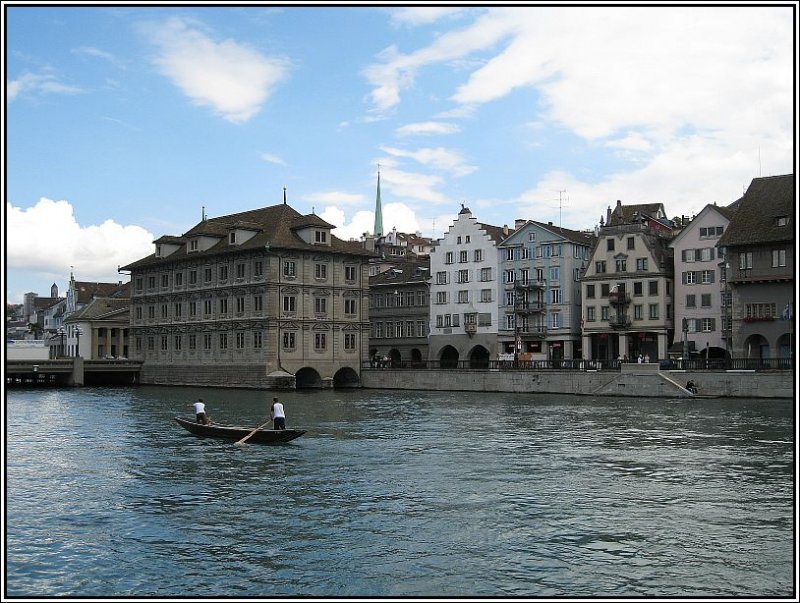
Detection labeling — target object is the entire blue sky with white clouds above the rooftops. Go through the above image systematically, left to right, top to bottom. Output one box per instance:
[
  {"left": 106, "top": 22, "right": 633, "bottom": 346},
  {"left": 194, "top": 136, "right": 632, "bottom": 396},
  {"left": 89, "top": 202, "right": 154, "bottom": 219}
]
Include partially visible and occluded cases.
[{"left": 3, "top": 3, "right": 797, "bottom": 303}]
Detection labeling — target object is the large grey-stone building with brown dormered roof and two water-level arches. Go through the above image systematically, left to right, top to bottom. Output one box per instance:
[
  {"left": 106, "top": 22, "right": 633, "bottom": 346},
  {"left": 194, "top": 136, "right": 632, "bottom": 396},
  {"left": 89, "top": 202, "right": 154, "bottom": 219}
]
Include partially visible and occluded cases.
[{"left": 123, "top": 200, "right": 373, "bottom": 388}]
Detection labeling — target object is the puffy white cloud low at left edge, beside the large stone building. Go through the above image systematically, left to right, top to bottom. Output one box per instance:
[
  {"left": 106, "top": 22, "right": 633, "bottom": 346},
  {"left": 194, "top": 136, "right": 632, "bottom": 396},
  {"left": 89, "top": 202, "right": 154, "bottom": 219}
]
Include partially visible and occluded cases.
[{"left": 5, "top": 197, "right": 155, "bottom": 282}]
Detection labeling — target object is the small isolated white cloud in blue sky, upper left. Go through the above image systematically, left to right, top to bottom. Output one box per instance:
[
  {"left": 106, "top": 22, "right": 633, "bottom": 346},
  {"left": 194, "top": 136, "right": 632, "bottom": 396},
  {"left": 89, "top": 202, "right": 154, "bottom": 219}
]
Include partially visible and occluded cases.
[{"left": 143, "top": 18, "right": 289, "bottom": 123}]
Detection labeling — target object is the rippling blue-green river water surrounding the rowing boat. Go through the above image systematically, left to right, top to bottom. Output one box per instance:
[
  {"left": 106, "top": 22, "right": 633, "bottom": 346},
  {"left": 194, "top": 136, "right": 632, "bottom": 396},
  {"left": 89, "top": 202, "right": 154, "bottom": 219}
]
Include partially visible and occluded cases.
[{"left": 5, "top": 387, "right": 795, "bottom": 597}]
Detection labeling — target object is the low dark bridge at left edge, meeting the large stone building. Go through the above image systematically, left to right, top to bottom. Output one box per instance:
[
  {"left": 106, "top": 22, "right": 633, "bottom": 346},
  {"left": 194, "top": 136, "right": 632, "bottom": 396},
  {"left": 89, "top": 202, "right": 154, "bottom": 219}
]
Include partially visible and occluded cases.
[{"left": 5, "top": 358, "right": 142, "bottom": 386}]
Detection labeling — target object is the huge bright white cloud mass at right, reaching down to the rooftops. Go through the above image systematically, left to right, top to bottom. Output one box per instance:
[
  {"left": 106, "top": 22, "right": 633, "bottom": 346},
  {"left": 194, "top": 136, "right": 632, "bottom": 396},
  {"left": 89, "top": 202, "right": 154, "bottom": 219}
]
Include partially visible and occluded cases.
[{"left": 365, "top": 6, "right": 795, "bottom": 228}]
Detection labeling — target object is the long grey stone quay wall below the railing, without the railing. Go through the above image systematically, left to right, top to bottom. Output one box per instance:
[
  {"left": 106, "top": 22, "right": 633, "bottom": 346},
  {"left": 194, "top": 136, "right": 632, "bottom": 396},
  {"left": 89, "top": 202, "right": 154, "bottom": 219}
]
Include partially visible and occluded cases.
[{"left": 361, "top": 363, "right": 796, "bottom": 399}]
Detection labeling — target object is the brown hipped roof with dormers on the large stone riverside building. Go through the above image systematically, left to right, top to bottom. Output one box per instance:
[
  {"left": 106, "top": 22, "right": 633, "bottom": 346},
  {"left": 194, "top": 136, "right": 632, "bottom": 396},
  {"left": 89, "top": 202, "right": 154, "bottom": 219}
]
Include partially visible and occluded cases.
[{"left": 123, "top": 203, "right": 375, "bottom": 270}]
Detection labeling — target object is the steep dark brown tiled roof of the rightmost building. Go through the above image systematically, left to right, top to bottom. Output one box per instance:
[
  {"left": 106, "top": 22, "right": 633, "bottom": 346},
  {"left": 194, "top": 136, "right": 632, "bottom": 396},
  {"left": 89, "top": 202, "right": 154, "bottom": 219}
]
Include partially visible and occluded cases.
[{"left": 717, "top": 174, "right": 795, "bottom": 247}]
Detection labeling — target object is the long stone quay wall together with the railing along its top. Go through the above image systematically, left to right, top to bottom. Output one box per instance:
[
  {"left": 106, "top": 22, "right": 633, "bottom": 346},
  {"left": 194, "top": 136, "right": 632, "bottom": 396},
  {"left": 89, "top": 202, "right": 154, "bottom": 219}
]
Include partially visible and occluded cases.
[{"left": 361, "top": 358, "right": 795, "bottom": 398}]
